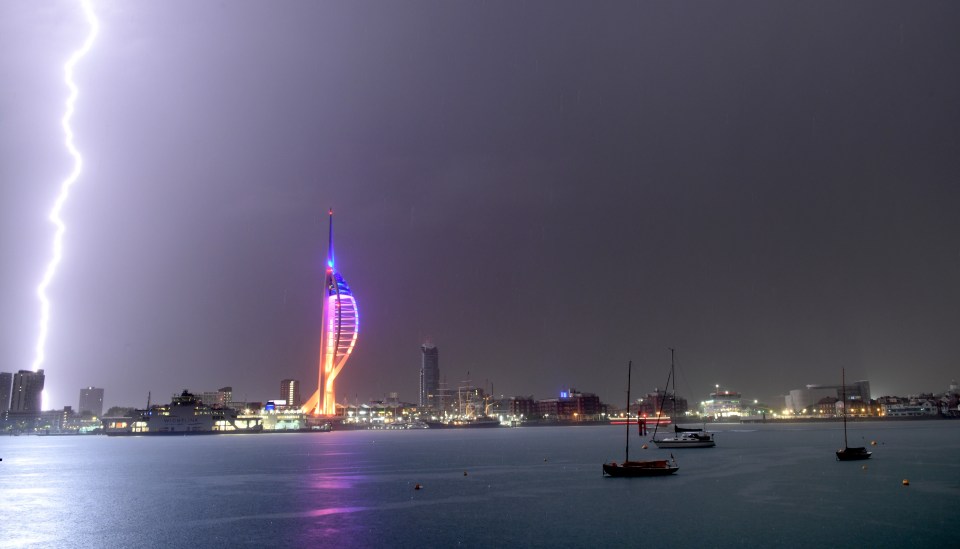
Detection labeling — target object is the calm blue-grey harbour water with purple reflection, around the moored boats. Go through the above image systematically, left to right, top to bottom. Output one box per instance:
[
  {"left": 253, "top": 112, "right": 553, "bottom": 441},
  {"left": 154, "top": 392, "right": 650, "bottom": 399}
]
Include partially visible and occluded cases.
[{"left": 0, "top": 420, "right": 960, "bottom": 547}]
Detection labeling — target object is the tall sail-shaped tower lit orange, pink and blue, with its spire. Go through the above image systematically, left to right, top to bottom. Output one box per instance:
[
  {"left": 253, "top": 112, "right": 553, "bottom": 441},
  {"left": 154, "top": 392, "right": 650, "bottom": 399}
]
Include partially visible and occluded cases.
[{"left": 303, "top": 210, "right": 360, "bottom": 416}]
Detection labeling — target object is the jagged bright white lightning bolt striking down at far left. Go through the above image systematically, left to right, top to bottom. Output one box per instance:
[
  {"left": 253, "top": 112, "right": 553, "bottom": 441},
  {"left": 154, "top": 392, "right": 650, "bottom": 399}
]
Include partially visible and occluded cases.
[{"left": 33, "top": 0, "right": 100, "bottom": 371}]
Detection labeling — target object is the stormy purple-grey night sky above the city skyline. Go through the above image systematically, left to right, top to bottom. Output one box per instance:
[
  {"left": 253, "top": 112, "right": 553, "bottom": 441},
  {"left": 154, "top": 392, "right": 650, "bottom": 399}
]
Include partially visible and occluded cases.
[{"left": 0, "top": 0, "right": 960, "bottom": 407}]
